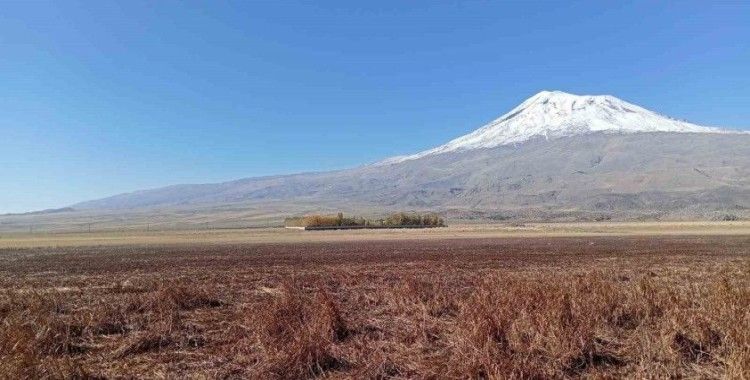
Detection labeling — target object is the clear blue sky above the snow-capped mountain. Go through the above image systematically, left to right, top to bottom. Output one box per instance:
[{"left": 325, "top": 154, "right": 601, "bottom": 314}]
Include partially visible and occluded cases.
[{"left": 0, "top": 0, "right": 750, "bottom": 213}]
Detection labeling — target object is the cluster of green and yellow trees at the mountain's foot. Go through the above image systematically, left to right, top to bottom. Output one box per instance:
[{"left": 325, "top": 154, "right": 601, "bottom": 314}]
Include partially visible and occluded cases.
[{"left": 284, "top": 212, "right": 445, "bottom": 227}]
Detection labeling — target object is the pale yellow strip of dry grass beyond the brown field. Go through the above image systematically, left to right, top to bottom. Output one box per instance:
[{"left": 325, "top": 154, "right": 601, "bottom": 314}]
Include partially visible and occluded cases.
[{"left": 0, "top": 221, "right": 750, "bottom": 248}]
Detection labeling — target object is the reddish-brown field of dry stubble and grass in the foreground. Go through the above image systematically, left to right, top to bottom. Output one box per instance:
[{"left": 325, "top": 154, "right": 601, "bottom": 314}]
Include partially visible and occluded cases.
[{"left": 0, "top": 232, "right": 750, "bottom": 379}]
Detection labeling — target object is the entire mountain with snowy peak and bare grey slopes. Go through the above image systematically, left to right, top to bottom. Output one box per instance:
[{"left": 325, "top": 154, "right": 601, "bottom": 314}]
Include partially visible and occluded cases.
[{"left": 73, "top": 92, "right": 750, "bottom": 219}]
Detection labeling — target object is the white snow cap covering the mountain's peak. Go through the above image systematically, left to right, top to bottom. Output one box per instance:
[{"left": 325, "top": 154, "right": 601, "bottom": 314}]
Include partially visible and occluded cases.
[{"left": 379, "top": 91, "right": 729, "bottom": 164}]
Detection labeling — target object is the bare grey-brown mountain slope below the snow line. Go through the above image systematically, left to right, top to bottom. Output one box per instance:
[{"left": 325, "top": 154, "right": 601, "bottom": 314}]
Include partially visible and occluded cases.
[{"left": 73, "top": 133, "right": 750, "bottom": 218}]
